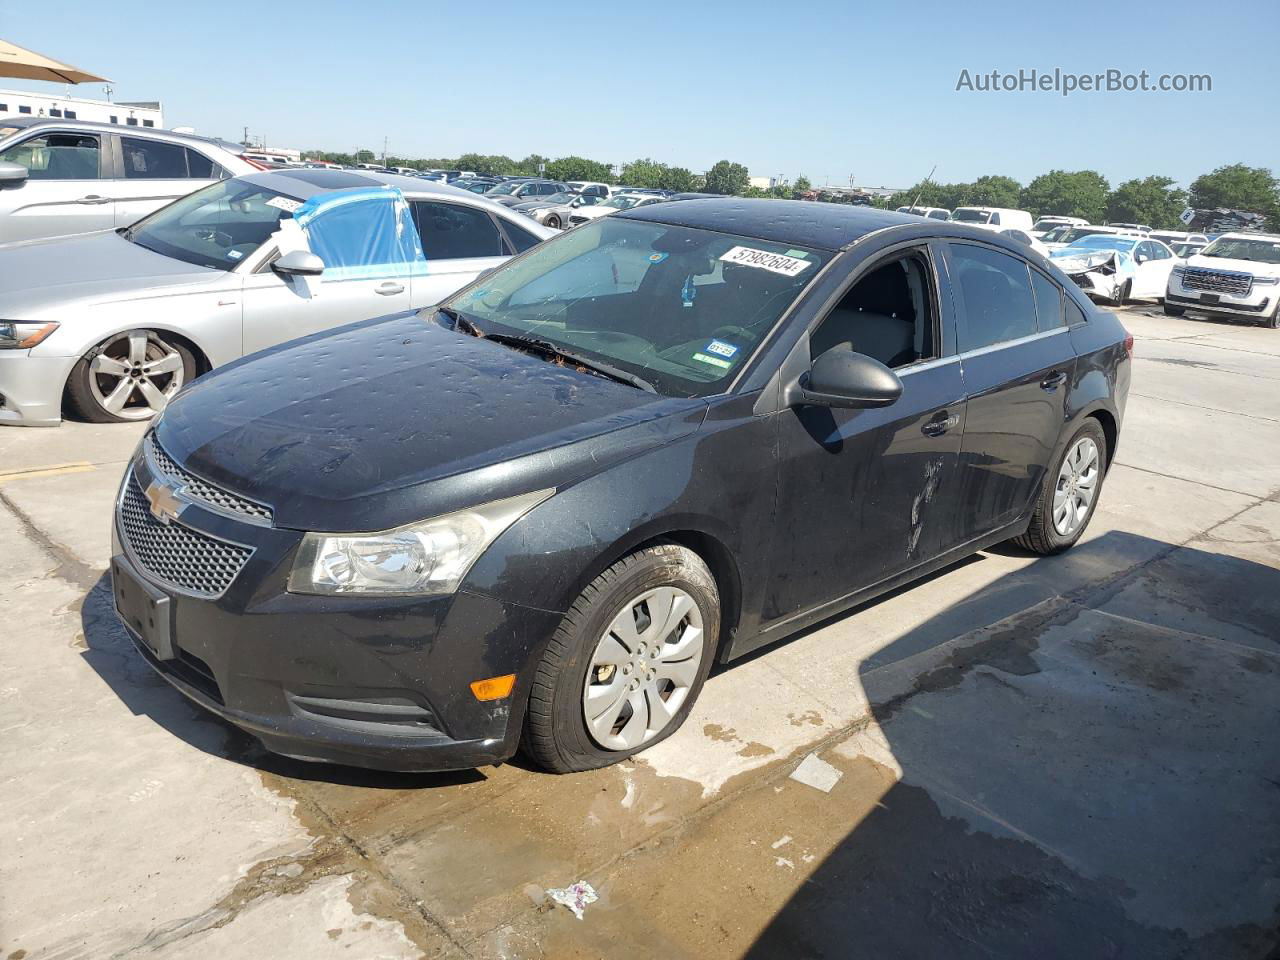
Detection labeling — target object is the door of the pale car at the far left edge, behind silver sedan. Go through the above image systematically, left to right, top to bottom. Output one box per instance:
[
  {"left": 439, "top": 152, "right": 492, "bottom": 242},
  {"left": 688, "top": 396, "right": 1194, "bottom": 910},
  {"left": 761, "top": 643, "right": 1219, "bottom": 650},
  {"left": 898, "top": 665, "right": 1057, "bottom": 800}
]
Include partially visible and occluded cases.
[{"left": 0, "top": 131, "right": 115, "bottom": 243}]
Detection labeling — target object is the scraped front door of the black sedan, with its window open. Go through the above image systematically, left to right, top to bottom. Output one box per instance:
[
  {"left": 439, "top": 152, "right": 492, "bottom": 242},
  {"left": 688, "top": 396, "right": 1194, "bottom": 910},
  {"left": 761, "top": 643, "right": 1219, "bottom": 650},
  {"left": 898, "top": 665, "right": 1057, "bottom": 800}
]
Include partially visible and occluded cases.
[{"left": 764, "top": 247, "right": 965, "bottom": 622}]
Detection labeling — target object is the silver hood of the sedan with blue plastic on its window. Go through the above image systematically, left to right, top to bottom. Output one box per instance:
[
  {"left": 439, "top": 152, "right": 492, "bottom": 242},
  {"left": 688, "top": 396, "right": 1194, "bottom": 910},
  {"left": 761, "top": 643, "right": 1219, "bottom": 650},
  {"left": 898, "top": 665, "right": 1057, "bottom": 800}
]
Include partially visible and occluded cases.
[{"left": 0, "top": 230, "right": 228, "bottom": 320}]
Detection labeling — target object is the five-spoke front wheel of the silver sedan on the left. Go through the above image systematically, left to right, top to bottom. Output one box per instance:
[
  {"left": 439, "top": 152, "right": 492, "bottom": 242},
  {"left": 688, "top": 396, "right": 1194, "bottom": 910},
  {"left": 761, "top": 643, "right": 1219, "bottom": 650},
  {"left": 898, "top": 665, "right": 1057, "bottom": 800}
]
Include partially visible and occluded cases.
[{"left": 67, "top": 329, "right": 197, "bottom": 424}]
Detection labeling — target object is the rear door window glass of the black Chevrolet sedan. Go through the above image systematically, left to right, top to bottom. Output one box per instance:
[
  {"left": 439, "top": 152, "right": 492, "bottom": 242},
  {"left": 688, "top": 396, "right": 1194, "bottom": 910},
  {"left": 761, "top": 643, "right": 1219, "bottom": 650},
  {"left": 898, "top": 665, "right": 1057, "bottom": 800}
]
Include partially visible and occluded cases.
[{"left": 951, "top": 243, "right": 1038, "bottom": 352}]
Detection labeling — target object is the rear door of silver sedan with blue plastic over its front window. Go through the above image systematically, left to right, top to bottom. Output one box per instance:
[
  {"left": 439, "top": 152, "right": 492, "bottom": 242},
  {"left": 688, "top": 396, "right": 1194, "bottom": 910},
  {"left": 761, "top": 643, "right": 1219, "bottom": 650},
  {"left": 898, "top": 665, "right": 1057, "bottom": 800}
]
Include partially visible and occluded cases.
[{"left": 410, "top": 200, "right": 509, "bottom": 307}]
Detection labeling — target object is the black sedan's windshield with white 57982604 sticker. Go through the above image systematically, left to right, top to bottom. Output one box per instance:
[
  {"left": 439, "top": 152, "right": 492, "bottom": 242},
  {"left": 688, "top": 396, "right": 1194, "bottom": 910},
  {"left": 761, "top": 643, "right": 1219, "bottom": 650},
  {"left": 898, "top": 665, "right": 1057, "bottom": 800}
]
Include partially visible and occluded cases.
[{"left": 445, "top": 216, "right": 831, "bottom": 397}]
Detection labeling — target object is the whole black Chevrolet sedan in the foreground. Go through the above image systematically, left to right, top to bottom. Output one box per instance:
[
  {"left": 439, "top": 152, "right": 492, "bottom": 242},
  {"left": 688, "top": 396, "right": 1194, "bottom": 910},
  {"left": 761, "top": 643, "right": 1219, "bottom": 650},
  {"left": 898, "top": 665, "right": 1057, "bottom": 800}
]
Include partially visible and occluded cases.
[{"left": 113, "top": 198, "right": 1133, "bottom": 771}]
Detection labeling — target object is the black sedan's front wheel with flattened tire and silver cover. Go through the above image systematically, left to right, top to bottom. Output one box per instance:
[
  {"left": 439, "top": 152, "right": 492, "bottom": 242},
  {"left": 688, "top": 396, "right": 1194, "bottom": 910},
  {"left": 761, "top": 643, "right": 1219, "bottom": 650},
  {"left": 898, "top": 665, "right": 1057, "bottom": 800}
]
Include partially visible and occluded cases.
[{"left": 521, "top": 544, "right": 721, "bottom": 773}]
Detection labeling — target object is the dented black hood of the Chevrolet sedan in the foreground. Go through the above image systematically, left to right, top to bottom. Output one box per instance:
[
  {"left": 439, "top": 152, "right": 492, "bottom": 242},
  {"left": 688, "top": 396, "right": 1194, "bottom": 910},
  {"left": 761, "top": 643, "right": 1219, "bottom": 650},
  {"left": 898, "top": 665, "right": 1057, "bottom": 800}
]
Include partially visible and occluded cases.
[{"left": 156, "top": 314, "right": 707, "bottom": 531}]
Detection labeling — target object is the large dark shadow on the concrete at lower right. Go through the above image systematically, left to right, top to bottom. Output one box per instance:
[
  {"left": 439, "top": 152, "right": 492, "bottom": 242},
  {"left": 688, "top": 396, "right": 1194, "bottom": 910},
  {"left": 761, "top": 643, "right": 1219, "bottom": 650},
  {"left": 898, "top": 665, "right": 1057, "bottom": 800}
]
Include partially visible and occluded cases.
[{"left": 745, "top": 531, "right": 1280, "bottom": 960}]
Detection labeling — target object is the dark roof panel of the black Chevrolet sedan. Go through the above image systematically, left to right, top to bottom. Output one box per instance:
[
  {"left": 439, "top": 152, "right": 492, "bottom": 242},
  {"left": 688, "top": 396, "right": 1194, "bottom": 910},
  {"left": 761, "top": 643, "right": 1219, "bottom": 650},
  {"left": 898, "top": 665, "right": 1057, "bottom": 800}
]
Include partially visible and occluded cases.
[{"left": 614, "top": 197, "right": 931, "bottom": 250}]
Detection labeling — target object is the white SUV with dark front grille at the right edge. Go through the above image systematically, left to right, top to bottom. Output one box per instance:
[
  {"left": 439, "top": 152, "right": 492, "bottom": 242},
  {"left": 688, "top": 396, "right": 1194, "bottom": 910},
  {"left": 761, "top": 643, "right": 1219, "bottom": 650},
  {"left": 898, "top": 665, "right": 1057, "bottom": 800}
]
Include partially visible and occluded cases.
[{"left": 1165, "top": 233, "right": 1280, "bottom": 329}]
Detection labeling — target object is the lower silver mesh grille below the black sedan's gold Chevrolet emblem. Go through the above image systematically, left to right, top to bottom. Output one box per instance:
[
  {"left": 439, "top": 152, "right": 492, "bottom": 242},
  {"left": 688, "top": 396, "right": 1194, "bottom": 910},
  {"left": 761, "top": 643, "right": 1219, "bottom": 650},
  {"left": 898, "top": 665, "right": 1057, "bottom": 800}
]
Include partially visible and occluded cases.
[{"left": 120, "top": 471, "right": 253, "bottom": 598}]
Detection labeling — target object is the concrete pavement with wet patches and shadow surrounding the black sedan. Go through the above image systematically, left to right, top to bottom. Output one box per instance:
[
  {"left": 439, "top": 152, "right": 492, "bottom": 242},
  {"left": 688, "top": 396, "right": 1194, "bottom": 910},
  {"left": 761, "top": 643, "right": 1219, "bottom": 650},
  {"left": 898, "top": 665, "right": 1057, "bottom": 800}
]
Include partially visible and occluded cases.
[{"left": 0, "top": 308, "right": 1280, "bottom": 960}]
